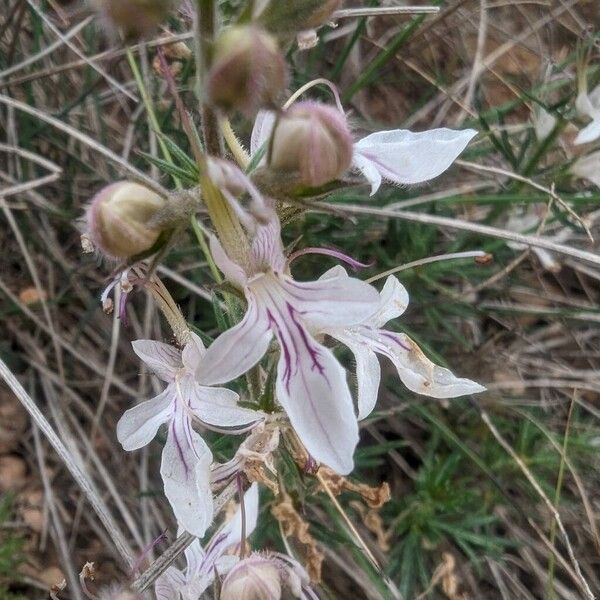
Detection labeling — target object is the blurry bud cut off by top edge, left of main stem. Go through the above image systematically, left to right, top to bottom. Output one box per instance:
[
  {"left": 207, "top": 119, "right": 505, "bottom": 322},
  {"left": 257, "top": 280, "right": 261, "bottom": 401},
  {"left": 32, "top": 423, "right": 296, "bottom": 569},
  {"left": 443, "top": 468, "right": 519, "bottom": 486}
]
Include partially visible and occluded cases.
[{"left": 95, "top": 0, "right": 179, "bottom": 38}]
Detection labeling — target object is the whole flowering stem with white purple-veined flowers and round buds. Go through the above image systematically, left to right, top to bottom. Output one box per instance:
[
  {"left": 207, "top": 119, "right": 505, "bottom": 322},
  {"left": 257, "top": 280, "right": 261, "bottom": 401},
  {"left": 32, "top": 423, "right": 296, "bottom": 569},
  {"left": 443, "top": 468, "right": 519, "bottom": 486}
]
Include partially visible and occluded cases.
[{"left": 85, "top": 0, "right": 488, "bottom": 600}]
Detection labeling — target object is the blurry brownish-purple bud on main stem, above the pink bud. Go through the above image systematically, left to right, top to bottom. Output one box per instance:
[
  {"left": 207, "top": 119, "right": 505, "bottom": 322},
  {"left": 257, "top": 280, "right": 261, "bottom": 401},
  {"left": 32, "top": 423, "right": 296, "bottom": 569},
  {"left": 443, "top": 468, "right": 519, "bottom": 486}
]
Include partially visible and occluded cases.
[{"left": 207, "top": 25, "right": 287, "bottom": 115}]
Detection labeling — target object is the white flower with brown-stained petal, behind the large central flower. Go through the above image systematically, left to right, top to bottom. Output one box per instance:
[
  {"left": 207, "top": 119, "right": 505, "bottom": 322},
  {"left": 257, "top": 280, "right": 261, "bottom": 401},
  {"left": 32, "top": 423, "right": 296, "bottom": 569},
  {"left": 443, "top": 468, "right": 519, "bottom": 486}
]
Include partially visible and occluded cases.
[{"left": 320, "top": 267, "right": 485, "bottom": 419}]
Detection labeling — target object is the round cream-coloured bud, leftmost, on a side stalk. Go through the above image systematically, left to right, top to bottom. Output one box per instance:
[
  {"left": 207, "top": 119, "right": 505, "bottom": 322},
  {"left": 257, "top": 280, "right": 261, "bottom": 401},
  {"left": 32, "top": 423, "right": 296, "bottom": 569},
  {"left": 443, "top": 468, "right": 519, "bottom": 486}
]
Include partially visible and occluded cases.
[{"left": 86, "top": 181, "right": 166, "bottom": 259}]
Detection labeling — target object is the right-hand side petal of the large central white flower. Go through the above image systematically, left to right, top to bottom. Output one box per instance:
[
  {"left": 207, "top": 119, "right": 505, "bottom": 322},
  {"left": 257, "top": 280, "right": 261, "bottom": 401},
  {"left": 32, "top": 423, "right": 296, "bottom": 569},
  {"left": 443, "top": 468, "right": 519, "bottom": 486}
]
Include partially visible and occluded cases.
[{"left": 280, "top": 271, "right": 379, "bottom": 331}]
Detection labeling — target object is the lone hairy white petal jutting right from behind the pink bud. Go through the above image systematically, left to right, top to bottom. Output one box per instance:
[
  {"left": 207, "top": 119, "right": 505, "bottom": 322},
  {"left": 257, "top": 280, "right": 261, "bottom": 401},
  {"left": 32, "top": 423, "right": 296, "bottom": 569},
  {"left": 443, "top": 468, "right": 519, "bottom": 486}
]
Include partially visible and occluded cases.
[{"left": 354, "top": 128, "right": 477, "bottom": 192}]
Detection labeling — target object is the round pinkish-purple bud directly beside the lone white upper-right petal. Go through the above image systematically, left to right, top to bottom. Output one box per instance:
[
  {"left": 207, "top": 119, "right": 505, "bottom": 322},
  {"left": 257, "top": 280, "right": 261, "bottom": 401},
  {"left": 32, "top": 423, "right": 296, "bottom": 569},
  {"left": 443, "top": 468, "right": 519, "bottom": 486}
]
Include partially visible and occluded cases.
[{"left": 269, "top": 102, "right": 352, "bottom": 187}]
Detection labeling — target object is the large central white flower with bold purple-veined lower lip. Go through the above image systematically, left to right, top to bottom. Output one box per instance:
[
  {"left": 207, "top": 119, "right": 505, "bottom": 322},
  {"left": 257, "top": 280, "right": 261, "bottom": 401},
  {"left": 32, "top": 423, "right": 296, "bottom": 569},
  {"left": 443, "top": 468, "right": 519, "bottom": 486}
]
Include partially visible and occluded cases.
[{"left": 196, "top": 213, "right": 379, "bottom": 474}]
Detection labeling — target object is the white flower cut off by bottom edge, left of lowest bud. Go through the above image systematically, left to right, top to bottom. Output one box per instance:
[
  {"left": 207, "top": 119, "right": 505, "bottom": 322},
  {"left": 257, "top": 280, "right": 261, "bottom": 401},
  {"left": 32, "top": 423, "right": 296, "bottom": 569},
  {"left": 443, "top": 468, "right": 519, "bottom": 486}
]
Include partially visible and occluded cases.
[{"left": 154, "top": 483, "right": 258, "bottom": 600}]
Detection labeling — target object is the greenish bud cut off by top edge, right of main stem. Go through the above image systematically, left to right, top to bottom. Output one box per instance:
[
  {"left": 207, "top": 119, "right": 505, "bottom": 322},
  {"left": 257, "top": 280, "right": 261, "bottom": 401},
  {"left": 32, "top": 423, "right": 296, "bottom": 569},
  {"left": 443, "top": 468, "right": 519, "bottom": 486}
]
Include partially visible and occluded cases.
[{"left": 254, "top": 0, "right": 342, "bottom": 33}]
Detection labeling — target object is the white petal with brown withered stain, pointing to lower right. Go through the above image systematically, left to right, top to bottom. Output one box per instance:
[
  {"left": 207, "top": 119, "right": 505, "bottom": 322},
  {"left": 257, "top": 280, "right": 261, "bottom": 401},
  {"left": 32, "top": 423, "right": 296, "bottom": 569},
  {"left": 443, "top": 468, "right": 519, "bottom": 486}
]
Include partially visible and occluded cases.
[{"left": 360, "top": 327, "right": 485, "bottom": 398}]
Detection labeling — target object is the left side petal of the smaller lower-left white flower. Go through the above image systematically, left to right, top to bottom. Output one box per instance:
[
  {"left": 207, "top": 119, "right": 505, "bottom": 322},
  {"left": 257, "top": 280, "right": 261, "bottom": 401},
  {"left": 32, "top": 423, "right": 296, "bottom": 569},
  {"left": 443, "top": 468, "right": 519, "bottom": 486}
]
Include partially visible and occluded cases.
[{"left": 117, "top": 385, "right": 173, "bottom": 450}]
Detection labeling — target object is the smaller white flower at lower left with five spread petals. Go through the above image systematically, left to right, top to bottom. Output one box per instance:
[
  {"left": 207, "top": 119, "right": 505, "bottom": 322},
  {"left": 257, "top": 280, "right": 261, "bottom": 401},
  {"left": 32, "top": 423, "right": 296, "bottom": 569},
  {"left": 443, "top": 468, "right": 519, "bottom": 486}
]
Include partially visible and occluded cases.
[{"left": 117, "top": 332, "right": 261, "bottom": 537}]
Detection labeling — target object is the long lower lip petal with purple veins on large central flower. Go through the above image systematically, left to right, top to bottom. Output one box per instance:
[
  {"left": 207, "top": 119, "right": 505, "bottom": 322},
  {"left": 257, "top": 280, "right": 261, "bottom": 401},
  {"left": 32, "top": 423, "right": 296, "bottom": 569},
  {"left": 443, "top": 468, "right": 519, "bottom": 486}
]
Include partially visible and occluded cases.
[{"left": 274, "top": 307, "right": 358, "bottom": 475}]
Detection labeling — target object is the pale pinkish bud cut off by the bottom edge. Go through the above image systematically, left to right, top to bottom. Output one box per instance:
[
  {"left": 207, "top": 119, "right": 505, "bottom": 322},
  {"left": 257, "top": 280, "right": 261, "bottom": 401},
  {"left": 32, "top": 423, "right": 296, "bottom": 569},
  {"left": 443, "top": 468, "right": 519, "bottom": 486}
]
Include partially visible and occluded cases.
[{"left": 221, "top": 554, "right": 281, "bottom": 600}]
